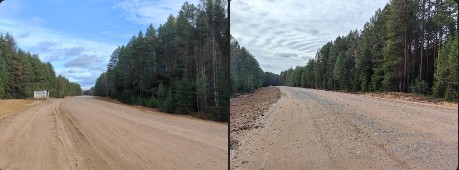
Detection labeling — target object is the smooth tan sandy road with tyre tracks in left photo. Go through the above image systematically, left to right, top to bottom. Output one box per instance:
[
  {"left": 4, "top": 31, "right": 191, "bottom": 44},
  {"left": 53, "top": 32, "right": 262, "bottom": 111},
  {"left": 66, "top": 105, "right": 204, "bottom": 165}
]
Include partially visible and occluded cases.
[{"left": 0, "top": 97, "right": 228, "bottom": 169}]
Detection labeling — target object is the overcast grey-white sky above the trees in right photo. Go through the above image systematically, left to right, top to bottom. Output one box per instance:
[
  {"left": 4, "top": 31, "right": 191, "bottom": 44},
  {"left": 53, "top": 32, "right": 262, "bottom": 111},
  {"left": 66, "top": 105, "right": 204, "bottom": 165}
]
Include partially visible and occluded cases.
[{"left": 230, "top": 0, "right": 389, "bottom": 74}]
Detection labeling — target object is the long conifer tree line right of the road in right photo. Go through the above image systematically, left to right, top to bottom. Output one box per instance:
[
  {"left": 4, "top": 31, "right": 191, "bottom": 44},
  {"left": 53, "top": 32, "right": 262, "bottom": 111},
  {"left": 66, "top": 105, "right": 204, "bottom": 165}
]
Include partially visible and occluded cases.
[{"left": 279, "top": 0, "right": 458, "bottom": 100}]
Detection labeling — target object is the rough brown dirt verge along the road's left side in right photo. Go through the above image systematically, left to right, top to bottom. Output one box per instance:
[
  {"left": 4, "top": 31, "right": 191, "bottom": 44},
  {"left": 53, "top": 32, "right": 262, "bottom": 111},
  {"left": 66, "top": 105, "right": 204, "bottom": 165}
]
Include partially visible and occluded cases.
[{"left": 230, "top": 87, "right": 281, "bottom": 149}]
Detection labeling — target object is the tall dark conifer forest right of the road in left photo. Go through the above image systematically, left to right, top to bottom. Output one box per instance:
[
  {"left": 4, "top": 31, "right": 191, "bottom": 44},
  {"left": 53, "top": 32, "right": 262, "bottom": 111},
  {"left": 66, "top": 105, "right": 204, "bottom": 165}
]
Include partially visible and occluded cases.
[{"left": 92, "top": 0, "right": 230, "bottom": 121}]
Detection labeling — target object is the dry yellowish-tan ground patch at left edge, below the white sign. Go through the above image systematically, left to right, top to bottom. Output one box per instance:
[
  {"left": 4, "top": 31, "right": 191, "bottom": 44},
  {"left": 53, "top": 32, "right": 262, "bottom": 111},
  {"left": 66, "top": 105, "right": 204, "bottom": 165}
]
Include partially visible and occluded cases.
[{"left": 0, "top": 99, "right": 44, "bottom": 118}]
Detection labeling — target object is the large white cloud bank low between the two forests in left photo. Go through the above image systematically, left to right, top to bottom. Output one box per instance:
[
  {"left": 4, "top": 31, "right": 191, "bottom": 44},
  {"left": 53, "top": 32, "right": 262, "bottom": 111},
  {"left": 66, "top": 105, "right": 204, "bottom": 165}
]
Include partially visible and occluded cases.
[{"left": 0, "top": 17, "right": 117, "bottom": 89}]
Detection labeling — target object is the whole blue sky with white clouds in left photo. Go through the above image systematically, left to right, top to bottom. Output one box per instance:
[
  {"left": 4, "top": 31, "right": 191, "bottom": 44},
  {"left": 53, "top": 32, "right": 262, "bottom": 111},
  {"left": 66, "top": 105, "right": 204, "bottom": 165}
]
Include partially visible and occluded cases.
[{"left": 0, "top": 0, "right": 199, "bottom": 90}]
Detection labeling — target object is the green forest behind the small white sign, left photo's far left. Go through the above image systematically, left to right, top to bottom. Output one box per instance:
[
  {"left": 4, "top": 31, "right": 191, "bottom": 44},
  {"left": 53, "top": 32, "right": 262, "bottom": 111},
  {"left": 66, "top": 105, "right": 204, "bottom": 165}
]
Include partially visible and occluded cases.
[{"left": 0, "top": 33, "right": 83, "bottom": 99}]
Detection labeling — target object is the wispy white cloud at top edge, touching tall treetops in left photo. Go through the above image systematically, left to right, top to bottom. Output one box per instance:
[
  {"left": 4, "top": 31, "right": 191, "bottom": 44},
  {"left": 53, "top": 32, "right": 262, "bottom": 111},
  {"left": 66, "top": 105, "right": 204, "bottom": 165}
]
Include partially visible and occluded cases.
[{"left": 113, "top": 0, "right": 199, "bottom": 25}]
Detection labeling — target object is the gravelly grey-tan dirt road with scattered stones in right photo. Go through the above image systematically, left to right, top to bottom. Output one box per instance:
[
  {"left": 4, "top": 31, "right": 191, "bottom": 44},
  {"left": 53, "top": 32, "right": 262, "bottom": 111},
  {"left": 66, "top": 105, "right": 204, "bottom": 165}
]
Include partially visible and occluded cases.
[{"left": 231, "top": 87, "right": 458, "bottom": 169}]
